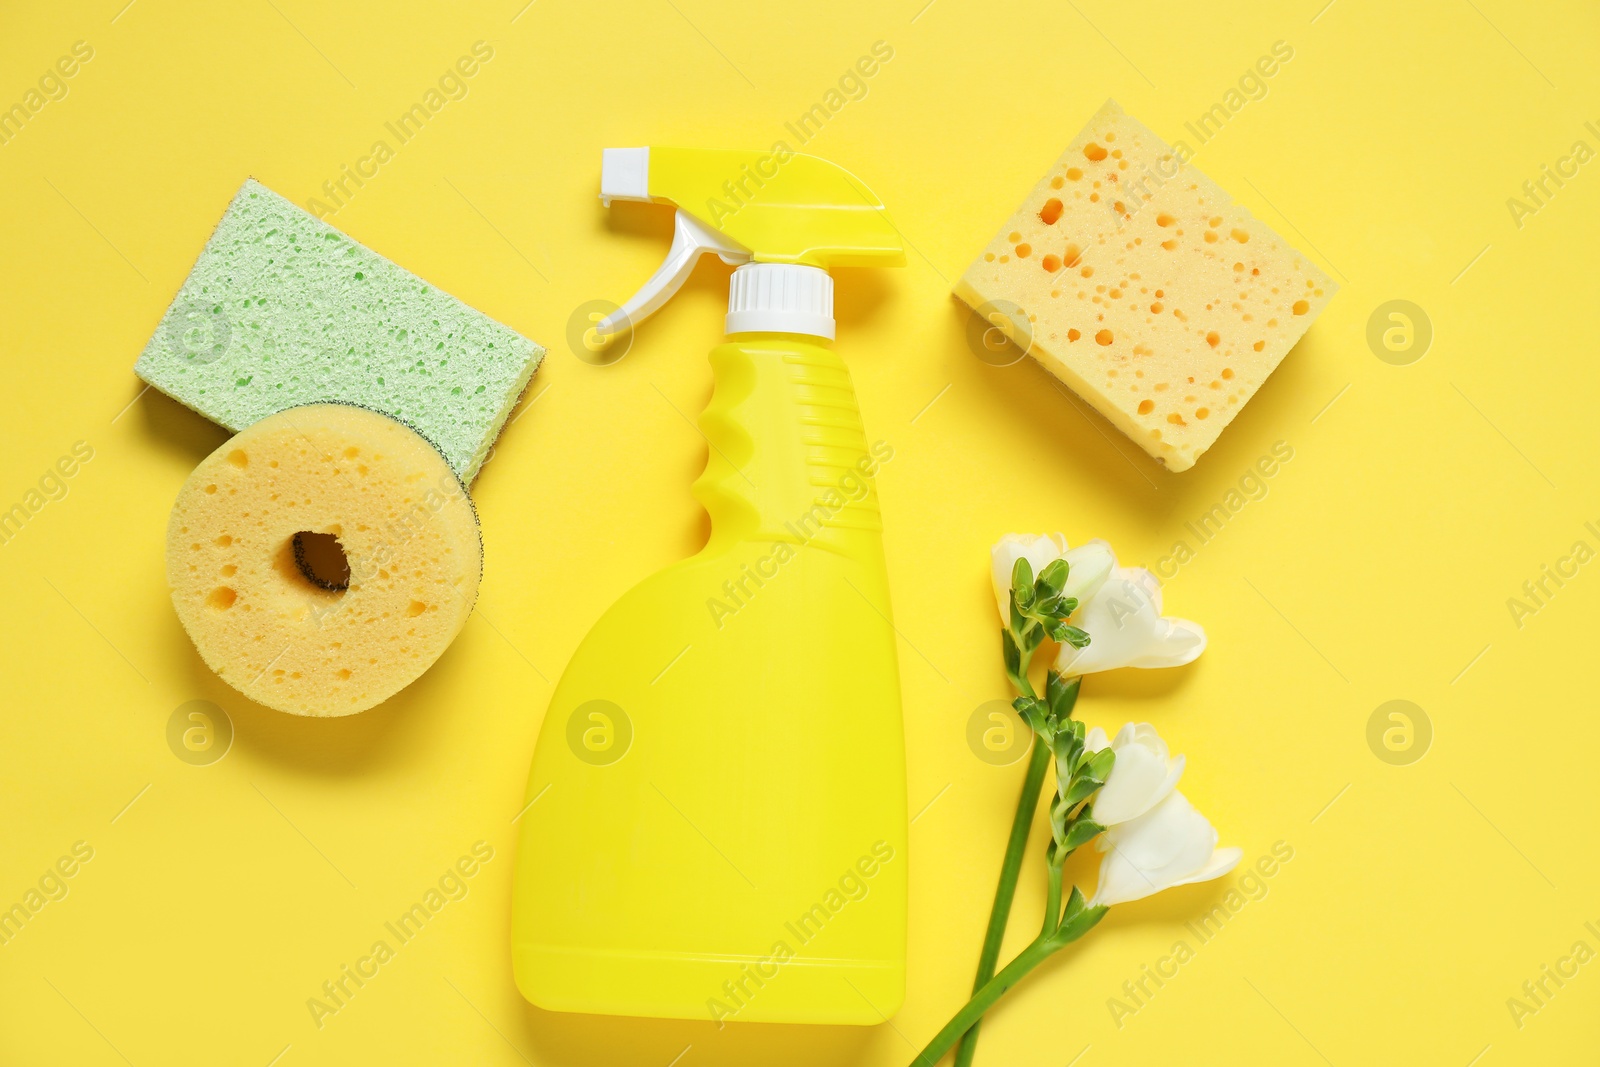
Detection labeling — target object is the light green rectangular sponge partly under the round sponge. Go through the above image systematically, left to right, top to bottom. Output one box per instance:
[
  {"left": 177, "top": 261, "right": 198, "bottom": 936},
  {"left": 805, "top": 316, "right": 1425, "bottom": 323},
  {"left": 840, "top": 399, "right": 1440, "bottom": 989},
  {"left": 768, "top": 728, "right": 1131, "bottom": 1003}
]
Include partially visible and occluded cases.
[{"left": 134, "top": 179, "right": 544, "bottom": 482}]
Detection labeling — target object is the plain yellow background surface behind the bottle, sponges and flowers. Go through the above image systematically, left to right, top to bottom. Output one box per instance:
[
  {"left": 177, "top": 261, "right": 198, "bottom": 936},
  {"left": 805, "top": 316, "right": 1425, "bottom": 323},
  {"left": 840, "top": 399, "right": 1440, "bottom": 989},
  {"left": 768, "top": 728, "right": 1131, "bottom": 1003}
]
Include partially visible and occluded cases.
[{"left": 0, "top": 0, "right": 1600, "bottom": 1067}]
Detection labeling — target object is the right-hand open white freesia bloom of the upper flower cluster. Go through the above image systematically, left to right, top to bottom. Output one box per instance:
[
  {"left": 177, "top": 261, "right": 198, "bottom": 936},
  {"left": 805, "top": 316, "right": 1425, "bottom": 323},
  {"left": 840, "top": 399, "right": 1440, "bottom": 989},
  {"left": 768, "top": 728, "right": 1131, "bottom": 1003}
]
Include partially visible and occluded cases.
[{"left": 1056, "top": 566, "right": 1205, "bottom": 677}]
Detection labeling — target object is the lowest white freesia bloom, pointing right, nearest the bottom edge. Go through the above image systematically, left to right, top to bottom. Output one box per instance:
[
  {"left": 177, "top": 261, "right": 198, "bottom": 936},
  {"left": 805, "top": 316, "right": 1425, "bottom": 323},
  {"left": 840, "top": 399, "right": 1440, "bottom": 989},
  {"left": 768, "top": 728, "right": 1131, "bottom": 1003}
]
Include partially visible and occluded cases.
[{"left": 1090, "top": 790, "right": 1243, "bottom": 907}]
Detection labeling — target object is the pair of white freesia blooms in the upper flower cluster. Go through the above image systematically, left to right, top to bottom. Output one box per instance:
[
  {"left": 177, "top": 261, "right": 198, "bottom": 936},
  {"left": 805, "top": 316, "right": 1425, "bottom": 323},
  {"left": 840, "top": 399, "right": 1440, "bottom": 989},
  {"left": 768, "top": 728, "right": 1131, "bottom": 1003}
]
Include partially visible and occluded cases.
[{"left": 990, "top": 534, "right": 1205, "bottom": 677}]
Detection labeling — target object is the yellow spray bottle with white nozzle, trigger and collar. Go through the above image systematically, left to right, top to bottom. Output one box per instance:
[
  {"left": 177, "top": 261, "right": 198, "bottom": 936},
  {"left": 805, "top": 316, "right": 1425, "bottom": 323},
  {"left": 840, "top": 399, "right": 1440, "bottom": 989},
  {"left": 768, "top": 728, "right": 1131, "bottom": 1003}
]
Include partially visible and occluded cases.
[{"left": 512, "top": 146, "right": 906, "bottom": 1024}]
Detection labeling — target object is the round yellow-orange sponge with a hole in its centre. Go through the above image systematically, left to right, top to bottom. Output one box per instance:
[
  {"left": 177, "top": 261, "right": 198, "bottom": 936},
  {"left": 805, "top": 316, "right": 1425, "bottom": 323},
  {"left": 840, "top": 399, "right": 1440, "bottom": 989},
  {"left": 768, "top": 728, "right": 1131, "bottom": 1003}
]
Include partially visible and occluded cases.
[{"left": 166, "top": 405, "right": 483, "bottom": 715}]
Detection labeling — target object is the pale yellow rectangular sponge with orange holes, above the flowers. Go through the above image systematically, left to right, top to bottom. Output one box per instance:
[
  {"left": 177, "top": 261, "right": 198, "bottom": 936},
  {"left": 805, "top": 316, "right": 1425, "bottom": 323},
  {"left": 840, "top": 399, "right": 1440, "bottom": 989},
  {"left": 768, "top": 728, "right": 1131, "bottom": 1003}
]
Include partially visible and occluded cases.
[{"left": 955, "top": 101, "right": 1339, "bottom": 470}]
